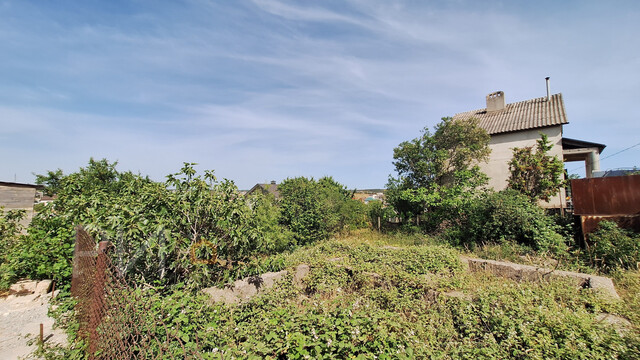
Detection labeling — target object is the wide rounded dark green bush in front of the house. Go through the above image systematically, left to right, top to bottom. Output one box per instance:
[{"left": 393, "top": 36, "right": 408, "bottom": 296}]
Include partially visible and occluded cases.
[{"left": 453, "top": 189, "right": 566, "bottom": 253}]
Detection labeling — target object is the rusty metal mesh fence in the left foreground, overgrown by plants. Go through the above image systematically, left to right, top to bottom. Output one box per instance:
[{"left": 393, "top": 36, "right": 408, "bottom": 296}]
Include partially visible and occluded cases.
[{"left": 71, "top": 227, "right": 202, "bottom": 359}]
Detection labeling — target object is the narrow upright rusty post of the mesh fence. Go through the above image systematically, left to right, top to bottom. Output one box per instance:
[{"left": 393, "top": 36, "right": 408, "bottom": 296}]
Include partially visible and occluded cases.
[{"left": 89, "top": 241, "right": 111, "bottom": 359}]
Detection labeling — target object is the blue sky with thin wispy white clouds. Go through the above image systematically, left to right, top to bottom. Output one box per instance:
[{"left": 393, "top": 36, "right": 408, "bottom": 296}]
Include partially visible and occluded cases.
[{"left": 0, "top": 0, "right": 640, "bottom": 189}]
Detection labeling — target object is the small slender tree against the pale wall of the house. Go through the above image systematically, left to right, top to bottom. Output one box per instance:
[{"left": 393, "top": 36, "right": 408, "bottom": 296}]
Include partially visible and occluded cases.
[{"left": 508, "top": 133, "right": 565, "bottom": 202}]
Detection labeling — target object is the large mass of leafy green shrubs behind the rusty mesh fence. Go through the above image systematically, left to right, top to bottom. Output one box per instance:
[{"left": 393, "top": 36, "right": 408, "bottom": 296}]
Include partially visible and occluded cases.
[{"left": 0, "top": 159, "right": 300, "bottom": 286}]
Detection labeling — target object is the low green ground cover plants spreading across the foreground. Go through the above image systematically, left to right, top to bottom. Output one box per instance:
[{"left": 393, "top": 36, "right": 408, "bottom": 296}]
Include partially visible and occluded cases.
[{"left": 41, "top": 231, "right": 640, "bottom": 359}]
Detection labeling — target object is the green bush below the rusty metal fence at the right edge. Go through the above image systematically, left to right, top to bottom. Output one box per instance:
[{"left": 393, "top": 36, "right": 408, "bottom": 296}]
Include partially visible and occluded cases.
[{"left": 586, "top": 220, "right": 640, "bottom": 272}]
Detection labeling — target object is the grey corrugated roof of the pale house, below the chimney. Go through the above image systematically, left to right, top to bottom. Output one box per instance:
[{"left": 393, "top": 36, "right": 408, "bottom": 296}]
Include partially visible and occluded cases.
[{"left": 453, "top": 94, "right": 569, "bottom": 135}]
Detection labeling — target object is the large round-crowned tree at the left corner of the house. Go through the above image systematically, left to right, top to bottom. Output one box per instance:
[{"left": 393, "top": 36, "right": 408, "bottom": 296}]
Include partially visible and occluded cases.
[{"left": 387, "top": 117, "right": 491, "bottom": 222}]
